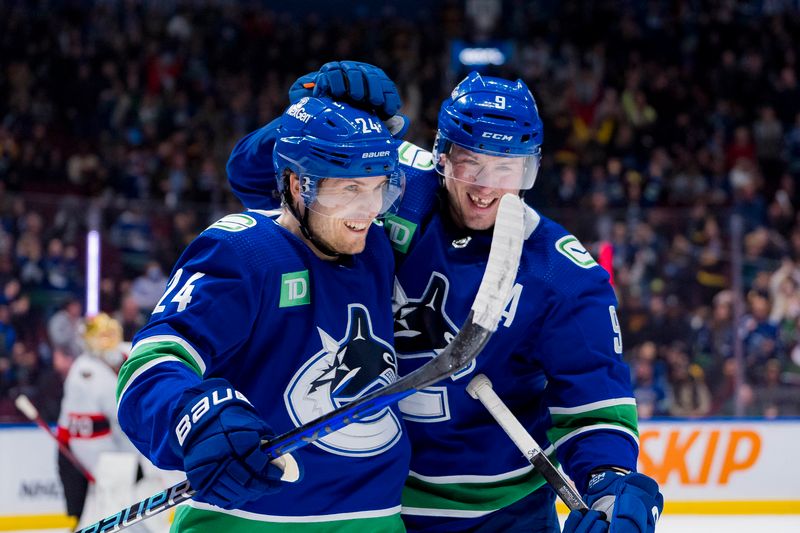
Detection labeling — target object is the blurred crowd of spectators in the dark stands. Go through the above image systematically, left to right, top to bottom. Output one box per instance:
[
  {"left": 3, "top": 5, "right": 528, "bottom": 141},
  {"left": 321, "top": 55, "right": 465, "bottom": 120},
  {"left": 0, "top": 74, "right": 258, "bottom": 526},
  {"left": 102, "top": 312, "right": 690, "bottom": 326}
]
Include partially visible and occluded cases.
[{"left": 0, "top": 0, "right": 800, "bottom": 421}]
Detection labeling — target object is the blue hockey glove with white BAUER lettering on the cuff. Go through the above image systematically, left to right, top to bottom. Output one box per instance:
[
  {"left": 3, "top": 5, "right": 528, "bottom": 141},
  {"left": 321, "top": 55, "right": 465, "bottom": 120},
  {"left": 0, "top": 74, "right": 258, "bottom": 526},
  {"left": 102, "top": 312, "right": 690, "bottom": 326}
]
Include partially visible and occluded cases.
[{"left": 170, "top": 378, "right": 290, "bottom": 509}]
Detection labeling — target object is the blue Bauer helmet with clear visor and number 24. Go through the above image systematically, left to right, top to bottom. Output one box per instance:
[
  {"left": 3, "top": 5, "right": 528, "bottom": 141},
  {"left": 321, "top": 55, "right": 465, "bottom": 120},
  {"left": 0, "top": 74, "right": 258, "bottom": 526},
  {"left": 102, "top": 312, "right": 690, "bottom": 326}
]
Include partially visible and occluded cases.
[{"left": 272, "top": 97, "right": 405, "bottom": 218}]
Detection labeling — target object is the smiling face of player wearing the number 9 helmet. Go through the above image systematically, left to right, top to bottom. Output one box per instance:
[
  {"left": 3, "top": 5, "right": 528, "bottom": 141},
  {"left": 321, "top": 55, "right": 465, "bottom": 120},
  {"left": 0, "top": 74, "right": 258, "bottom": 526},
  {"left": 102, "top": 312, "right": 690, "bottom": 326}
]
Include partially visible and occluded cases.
[{"left": 442, "top": 145, "right": 524, "bottom": 230}]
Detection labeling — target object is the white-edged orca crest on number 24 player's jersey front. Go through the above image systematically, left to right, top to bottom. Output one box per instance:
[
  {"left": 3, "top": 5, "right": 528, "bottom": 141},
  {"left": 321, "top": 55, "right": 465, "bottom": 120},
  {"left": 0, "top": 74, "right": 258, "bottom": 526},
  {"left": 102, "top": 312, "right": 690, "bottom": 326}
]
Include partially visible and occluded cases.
[{"left": 284, "top": 304, "right": 402, "bottom": 457}]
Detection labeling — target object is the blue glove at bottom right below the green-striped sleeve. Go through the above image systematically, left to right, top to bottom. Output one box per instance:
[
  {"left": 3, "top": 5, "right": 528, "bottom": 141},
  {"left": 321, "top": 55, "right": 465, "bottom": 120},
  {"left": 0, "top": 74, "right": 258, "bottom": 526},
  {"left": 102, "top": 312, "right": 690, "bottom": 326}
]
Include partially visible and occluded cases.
[{"left": 564, "top": 470, "right": 664, "bottom": 533}]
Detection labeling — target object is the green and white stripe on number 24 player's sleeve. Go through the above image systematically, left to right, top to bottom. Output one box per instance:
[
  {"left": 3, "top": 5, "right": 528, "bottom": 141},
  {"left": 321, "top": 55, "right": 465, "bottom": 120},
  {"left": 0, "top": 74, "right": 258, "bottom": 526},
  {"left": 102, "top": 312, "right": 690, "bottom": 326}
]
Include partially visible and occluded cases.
[{"left": 117, "top": 335, "right": 206, "bottom": 401}]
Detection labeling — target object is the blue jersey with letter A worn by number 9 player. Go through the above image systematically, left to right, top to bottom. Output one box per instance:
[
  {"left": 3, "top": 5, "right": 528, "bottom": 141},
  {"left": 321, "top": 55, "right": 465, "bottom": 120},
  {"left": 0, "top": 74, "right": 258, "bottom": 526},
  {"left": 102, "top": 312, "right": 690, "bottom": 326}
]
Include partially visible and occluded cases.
[{"left": 385, "top": 144, "right": 638, "bottom": 517}]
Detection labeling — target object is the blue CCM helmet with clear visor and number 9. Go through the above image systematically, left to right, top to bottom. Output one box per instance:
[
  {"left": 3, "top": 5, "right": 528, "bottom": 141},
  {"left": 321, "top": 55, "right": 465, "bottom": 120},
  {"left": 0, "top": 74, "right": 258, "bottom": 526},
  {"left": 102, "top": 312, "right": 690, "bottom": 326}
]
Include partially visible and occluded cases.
[{"left": 433, "top": 72, "right": 544, "bottom": 190}]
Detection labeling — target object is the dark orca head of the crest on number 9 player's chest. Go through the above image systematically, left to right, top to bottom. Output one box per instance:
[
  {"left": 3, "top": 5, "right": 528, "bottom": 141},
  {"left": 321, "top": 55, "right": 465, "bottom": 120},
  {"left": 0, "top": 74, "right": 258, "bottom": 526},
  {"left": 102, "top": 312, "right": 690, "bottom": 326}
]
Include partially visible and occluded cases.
[{"left": 394, "top": 272, "right": 475, "bottom": 379}]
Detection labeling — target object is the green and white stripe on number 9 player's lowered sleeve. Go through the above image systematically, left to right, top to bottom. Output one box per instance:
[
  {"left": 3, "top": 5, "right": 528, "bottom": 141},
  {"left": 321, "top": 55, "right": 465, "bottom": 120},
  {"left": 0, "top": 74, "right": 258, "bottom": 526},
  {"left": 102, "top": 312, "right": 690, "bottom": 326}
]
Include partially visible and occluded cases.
[{"left": 547, "top": 398, "right": 639, "bottom": 446}]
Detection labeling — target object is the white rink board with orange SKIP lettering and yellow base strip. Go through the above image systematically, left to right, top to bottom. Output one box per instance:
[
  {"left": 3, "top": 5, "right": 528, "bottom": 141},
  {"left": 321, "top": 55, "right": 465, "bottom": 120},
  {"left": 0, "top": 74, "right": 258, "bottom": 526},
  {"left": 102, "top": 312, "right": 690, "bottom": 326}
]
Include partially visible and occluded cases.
[{"left": 639, "top": 420, "right": 800, "bottom": 514}]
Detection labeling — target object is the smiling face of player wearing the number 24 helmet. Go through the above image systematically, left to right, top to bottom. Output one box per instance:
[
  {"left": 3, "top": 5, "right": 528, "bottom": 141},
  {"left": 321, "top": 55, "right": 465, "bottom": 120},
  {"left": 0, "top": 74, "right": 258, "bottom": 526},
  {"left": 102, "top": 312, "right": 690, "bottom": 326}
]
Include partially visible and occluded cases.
[{"left": 308, "top": 176, "right": 387, "bottom": 255}]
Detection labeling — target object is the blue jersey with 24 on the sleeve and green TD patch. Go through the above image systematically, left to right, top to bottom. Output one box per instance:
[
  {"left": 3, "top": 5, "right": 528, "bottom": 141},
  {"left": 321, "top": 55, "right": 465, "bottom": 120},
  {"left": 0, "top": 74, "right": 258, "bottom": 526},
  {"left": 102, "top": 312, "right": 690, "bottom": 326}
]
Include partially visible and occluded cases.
[{"left": 117, "top": 211, "right": 409, "bottom": 532}]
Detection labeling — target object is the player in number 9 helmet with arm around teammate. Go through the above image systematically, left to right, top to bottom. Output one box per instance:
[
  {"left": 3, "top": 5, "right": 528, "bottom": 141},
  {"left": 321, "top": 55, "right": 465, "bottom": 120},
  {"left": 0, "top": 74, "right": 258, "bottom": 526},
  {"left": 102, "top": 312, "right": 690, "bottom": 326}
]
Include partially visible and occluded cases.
[{"left": 223, "top": 62, "right": 663, "bottom": 533}]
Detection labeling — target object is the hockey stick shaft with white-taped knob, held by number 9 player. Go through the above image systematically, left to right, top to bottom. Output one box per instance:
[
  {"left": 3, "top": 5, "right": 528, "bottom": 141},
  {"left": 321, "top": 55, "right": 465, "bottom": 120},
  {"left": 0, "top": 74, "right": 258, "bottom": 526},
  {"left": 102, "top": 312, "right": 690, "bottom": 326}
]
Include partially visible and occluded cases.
[{"left": 467, "top": 374, "right": 588, "bottom": 511}]
